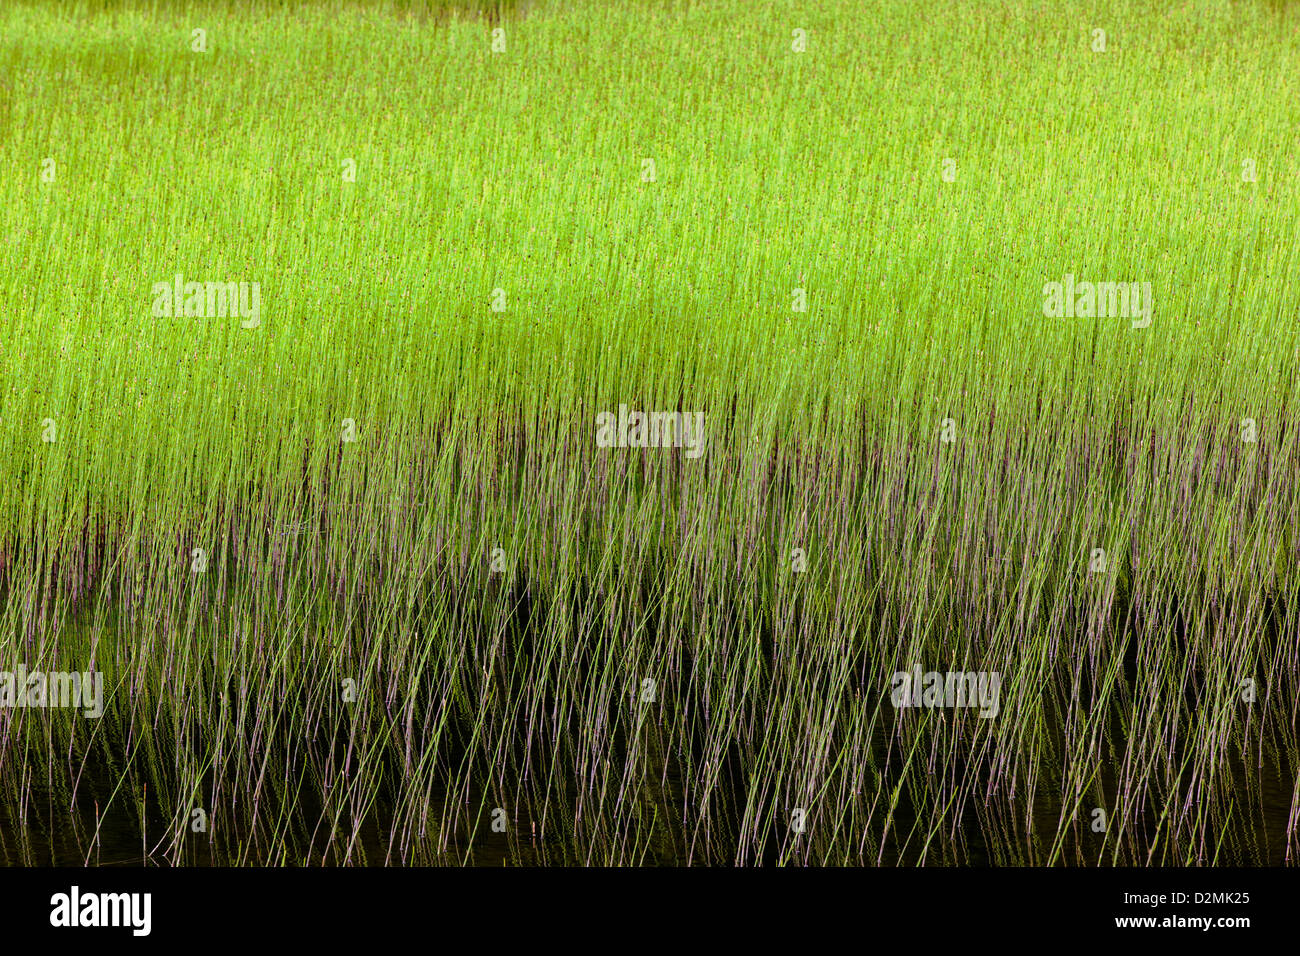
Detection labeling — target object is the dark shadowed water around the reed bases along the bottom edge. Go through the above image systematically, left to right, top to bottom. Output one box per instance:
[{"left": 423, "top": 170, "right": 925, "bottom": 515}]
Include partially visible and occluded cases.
[{"left": 0, "top": 723, "right": 1292, "bottom": 866}]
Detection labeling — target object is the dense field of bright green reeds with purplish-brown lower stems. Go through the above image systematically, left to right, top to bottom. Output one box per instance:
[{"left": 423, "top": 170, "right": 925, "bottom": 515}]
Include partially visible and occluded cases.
[{"left": 0, "top": 0, "right": 1300, "bottom": 865}]
